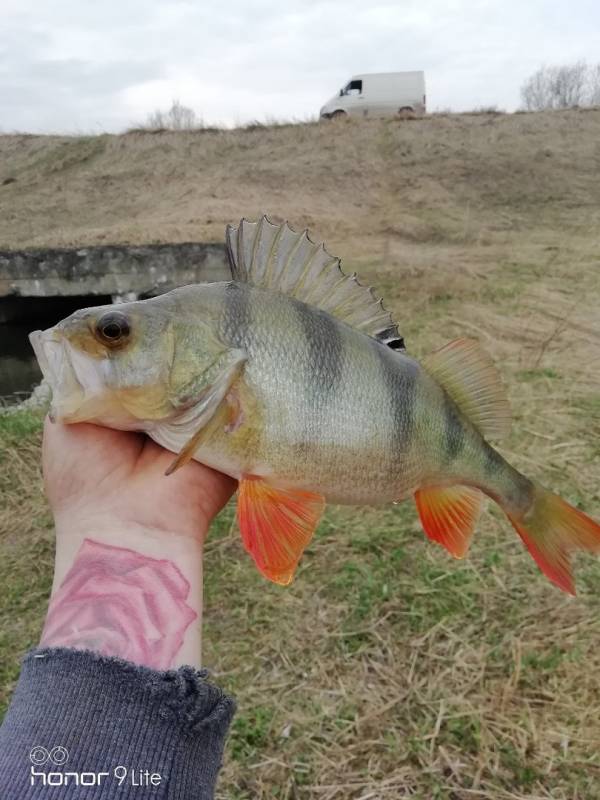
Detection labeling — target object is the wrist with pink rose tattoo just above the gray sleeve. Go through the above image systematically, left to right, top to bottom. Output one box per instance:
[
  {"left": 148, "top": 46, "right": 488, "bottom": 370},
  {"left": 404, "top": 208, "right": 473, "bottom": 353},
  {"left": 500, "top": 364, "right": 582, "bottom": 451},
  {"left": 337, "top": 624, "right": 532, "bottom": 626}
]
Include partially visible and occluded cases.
[{"left": 41, "top": 513, "right": 203, "bottom": 669}]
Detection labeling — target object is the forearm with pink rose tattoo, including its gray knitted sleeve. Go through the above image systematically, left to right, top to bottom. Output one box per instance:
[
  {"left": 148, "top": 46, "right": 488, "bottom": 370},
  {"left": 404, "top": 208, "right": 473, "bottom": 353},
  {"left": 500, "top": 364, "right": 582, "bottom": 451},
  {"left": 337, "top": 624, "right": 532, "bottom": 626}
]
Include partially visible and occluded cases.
[{"left": 0, "top": 515, "right": 234, "bottom": 800}]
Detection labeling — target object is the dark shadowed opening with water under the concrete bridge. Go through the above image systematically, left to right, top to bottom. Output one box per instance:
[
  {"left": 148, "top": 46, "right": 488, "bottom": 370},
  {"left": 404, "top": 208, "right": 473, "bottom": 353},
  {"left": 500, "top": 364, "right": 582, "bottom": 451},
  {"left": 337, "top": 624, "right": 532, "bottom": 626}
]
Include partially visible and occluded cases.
[{"left": 0, "top": 296, "right": 111, "bottom": 404}]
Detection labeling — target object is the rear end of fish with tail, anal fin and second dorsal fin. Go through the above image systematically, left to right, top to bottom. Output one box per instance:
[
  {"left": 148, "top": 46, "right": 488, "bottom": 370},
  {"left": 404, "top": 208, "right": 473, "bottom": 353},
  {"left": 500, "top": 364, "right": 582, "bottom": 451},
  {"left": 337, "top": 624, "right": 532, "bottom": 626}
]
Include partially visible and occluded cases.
[{"left": 415, "top": 339, "right": 600, "bottom": 594}]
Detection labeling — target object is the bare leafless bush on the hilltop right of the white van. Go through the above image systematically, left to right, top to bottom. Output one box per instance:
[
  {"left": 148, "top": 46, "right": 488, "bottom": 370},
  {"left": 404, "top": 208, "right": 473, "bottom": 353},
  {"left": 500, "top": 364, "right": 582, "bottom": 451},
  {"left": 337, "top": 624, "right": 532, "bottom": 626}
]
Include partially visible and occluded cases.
[{"left": 521, "top": 61, "right": 600, "bottom": 111}]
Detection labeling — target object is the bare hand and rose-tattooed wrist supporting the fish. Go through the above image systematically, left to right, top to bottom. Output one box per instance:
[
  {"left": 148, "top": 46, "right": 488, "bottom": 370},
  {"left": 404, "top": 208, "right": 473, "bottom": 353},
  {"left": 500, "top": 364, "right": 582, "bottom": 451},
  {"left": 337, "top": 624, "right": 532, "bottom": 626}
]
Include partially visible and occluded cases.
[{"left": 41, "top": 420, "right": 235, "bottom": 669}]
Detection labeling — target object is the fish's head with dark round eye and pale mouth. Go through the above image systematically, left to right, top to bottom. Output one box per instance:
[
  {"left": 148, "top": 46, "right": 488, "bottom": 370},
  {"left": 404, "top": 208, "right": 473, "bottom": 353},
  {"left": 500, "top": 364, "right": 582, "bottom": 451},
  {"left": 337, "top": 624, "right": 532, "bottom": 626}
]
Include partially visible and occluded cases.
[{"left": 29, "top": 295, "right": 225, "bottom": 430}]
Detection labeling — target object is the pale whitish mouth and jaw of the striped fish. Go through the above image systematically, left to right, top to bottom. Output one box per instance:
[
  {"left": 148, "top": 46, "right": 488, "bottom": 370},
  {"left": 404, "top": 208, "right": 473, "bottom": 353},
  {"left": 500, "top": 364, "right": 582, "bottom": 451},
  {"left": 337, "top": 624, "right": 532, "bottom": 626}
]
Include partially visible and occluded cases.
[{"left": 29, "top": 328, "right": 117, "bottom": 423}]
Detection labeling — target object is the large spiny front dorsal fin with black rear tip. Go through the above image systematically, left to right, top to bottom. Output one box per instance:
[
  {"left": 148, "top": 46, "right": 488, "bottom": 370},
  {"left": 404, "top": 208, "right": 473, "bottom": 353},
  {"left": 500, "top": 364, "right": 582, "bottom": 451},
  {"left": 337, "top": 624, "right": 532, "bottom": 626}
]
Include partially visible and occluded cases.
[{"left": 226, "top": 217, "right": 404, "bottom": 350}]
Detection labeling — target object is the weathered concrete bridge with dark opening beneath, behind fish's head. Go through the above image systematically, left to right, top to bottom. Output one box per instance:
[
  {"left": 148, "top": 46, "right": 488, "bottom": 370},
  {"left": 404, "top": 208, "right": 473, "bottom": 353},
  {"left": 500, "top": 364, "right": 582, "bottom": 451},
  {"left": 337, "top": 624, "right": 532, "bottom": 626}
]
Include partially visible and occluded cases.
[{"left": 0, "top": 243, "right": 230, "bottom": 404}]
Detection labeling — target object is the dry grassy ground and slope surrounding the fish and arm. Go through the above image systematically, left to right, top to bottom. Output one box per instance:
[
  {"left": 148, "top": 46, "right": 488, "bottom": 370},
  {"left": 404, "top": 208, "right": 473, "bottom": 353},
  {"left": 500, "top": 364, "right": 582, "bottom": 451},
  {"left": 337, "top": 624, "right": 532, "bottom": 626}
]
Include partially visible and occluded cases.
[{"left": 0, "top": 111, "right": 600, "bottom": 800}]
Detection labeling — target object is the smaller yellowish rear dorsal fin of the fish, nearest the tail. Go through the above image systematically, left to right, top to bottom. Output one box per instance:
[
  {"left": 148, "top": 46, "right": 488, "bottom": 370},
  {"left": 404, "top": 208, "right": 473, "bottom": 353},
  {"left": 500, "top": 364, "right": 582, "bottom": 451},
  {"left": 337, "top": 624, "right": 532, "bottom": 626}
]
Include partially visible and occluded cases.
[{"left": 423, "top": 339, "right": 511, "bottom": 439}]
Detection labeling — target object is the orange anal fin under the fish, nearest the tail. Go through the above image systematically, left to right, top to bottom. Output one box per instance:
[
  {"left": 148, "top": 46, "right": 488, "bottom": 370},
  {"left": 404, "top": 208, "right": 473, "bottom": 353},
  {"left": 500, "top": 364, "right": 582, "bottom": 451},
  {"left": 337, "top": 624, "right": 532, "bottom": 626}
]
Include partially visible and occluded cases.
[{"left": 415, "top": 486, "right": 483, "bottom": 558}]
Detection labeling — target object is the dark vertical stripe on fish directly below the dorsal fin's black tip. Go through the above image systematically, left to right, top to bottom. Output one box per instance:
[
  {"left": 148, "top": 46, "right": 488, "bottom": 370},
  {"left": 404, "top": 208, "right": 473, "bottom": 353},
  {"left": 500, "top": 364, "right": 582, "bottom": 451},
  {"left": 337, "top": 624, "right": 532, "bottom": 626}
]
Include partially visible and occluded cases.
[{"left": 373, "top": 340, "right": 419, "bottom": 463}]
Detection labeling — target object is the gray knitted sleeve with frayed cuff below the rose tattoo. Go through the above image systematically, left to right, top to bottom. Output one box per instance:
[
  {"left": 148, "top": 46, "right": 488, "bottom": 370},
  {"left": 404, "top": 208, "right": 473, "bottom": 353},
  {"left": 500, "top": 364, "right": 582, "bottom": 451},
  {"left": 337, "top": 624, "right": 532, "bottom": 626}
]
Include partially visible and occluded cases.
[{"left": 0, "top": 648, "right": 235, "bottom": 800}]
